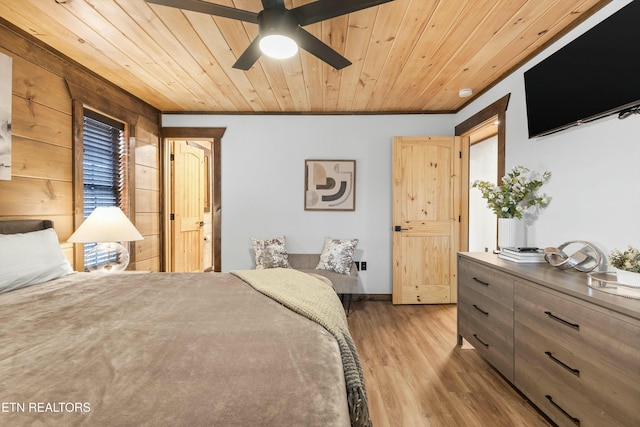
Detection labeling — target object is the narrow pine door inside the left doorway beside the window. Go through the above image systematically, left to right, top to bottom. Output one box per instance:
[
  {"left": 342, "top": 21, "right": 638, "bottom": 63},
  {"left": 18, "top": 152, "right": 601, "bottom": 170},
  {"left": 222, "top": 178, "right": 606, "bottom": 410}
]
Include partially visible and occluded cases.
[{"left": 171, "top": 141, "right": 204, "bottom": 272}]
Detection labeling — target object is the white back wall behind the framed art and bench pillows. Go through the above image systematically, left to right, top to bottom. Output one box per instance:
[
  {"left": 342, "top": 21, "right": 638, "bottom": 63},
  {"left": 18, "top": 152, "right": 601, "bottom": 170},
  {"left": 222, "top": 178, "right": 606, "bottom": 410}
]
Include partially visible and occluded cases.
[{"left": 163, "top": 115, "right": 454, "bottom": 294}]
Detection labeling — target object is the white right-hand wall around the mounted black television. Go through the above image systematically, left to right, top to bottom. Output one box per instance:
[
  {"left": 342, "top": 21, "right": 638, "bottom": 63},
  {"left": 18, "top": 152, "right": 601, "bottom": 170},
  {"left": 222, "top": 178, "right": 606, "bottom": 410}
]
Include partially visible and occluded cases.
[{"left": 455, "top": 0, "right": 640, "bottom": 260}]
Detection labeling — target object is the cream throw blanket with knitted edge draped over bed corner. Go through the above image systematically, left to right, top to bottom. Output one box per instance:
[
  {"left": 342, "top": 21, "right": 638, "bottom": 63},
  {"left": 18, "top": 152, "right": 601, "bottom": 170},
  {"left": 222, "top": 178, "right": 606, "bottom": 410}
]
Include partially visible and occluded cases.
[{"left": 231, "top": 268, "right": 371, "bottom": 427}]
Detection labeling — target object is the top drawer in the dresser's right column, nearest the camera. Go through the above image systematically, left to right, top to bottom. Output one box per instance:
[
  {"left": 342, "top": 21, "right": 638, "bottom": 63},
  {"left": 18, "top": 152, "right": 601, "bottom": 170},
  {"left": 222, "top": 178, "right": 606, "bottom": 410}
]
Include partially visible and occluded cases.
[{"left": 514, "top": 281, "right": 640, "bottom": 372}]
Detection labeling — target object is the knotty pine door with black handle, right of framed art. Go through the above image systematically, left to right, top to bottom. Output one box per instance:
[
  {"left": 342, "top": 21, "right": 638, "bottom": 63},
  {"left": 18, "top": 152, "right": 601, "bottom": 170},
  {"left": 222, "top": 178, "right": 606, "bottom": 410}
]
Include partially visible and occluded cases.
[{"left": 392, "top": 136, "right": 462, "bottom": 304}]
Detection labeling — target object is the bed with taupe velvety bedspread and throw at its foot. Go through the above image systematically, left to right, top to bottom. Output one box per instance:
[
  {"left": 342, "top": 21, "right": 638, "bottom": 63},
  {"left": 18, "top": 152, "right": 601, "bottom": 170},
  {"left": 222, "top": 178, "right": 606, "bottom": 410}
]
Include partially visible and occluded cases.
[{"left": 0, "top": 221, "right": 370, "bottom": 426}]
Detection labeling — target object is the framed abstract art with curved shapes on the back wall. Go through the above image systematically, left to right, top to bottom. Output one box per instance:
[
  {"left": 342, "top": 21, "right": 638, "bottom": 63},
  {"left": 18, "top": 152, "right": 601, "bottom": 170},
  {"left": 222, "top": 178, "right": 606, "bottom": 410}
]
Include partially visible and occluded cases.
[{"left": 304, "top": 159, "right": 356, "bottom": 211}]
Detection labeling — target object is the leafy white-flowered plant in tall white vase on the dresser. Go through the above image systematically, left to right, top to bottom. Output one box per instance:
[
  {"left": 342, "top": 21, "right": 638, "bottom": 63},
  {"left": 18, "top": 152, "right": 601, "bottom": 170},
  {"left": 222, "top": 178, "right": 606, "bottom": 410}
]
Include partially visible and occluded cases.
[{"left": 472, "top": 166, "right": 551, "bottom": 248}]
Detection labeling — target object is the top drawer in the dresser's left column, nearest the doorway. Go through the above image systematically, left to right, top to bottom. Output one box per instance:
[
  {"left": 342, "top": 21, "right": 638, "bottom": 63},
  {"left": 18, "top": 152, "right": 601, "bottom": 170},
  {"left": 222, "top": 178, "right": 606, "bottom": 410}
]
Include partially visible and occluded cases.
[{"left": 458, "top": 258, "right": 513, "bottom": 308}]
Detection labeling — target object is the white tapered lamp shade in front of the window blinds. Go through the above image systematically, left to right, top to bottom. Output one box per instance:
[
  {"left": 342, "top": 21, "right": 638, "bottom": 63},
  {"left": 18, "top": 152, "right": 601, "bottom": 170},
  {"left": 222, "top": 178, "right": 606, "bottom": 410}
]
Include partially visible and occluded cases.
[{"left": 67, "top": 206, "right": 143, "bottom": 243}]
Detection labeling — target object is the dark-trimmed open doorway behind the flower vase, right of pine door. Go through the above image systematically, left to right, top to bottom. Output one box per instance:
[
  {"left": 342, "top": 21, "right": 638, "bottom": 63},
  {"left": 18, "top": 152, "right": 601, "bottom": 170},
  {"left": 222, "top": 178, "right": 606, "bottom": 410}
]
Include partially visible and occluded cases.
[{"left": 455, "top": 94, "right": 510, "bottom": 252}]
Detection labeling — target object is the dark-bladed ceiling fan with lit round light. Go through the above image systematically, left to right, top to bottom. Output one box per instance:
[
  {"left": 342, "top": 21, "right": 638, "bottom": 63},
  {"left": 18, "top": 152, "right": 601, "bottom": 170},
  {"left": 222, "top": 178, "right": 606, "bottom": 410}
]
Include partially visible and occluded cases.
[{"left": 146, "top": 0, "right": 393, "bottom": 70}]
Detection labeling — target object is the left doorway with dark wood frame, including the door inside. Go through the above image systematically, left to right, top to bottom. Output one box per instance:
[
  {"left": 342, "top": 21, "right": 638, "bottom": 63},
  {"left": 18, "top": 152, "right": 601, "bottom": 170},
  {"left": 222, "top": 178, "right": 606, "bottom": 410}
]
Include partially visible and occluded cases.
[{"left": 162, "top": 128, "right": 225, "bottom": 271}]
